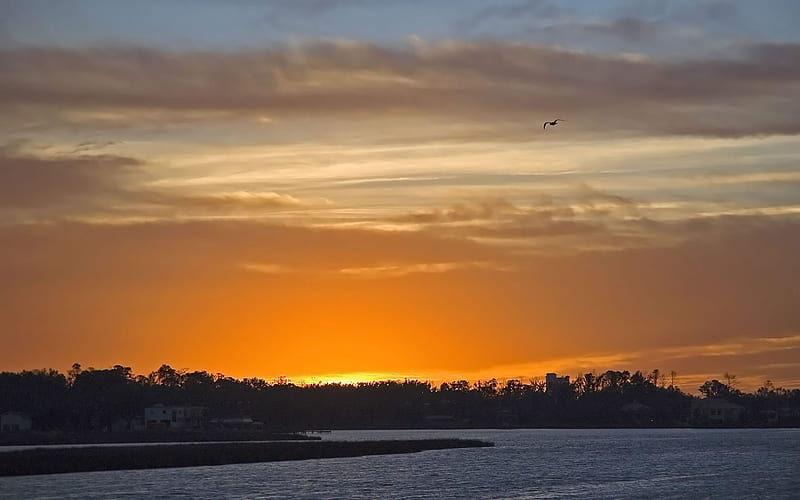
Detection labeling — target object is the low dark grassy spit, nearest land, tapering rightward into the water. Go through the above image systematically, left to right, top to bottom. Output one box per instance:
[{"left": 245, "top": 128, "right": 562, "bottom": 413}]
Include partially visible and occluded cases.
[{"left": 0, "top": 439, "right": 494, "bottom": 476}]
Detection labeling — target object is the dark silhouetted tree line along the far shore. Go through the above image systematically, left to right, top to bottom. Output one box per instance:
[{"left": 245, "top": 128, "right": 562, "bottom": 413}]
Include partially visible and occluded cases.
[{"left": 0, "top": 364, "right": 800, "bottom": 431}]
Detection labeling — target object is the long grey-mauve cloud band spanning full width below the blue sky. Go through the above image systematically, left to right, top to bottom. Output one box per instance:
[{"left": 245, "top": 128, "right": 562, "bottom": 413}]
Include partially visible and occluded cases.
[{"left": 0, "top": 40, "right": 800, "bottom": 140}]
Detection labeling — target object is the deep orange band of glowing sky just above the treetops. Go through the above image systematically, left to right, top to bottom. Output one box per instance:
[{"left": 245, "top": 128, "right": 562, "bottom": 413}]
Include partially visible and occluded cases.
[{"left": 2, "top": 221, "right": 800, "bottom": 390}]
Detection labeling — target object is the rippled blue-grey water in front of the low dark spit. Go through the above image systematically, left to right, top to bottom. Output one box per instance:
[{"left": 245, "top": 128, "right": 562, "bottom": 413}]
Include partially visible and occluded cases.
[{"left": 0, "top": 429, "right": 800, "bottom": 500}]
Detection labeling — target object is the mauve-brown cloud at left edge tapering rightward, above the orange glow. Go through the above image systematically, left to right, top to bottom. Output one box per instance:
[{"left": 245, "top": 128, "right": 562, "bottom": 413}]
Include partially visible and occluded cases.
[{"left": 0, "top": 140, "right": 312, "bottom": 221}]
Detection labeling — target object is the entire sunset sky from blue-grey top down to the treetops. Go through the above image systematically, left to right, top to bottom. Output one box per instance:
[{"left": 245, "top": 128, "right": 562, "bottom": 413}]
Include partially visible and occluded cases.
[{"left": 0, "top": 0, "right": 800, "bottom": 392}]
